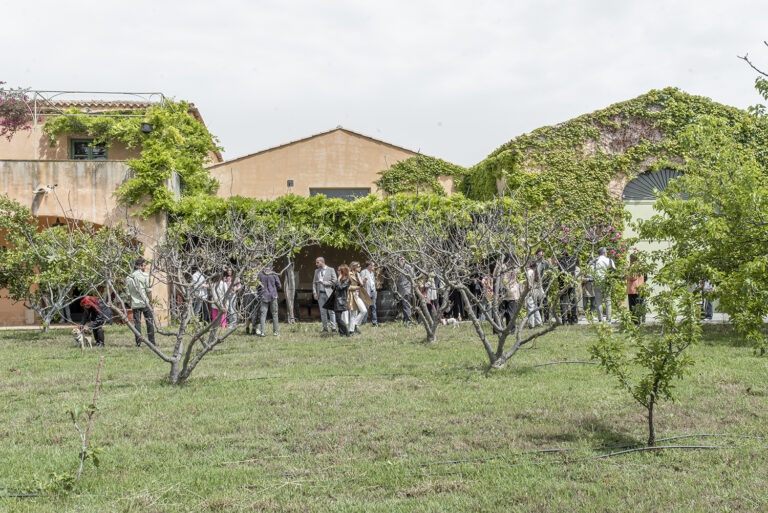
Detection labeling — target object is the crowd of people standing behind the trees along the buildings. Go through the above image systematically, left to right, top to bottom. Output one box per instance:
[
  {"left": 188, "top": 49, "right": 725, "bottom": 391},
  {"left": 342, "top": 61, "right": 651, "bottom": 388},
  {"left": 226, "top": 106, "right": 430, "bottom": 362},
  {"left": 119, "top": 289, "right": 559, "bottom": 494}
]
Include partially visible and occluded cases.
[{"left": 70, "top": 247, "right": 712, "bottom": 346}]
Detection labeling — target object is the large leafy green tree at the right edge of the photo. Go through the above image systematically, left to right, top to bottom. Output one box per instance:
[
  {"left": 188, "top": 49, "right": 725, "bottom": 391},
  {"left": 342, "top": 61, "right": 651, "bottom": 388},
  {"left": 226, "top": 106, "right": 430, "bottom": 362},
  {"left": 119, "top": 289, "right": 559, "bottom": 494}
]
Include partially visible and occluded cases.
[{"left": 640, "top": 116, "right": 768, "bottom": 353}]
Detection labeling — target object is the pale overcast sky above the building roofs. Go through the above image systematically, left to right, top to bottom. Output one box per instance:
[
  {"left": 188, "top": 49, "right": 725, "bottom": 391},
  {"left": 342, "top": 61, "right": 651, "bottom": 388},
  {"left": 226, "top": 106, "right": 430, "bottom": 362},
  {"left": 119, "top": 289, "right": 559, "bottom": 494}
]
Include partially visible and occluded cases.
[{"left": 0, "top": 0, "right": 768, "bottom": 166}]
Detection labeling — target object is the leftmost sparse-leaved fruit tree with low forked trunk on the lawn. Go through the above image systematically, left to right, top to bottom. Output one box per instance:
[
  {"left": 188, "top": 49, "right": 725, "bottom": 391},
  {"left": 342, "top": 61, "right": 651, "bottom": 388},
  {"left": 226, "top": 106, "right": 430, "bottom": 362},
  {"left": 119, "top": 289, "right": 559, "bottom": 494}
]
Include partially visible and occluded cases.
[{"left": 51, "top": 208, "right": 317, "bottom": 385}]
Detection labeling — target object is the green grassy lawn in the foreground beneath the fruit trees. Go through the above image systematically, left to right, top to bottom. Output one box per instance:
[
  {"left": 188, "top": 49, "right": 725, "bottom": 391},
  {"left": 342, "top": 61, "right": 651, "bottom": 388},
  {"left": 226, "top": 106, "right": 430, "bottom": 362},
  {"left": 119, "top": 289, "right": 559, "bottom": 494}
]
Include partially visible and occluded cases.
[{"left": 0, "top": 324, "right": 768, "bottom": 512}]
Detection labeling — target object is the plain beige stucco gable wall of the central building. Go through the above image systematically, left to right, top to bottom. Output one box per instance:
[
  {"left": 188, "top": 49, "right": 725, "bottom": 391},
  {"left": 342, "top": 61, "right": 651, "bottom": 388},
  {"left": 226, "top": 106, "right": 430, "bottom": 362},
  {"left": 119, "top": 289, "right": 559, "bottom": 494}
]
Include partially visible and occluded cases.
[{"left": 209, "top": 129, "right": 416, "bottom": 199}]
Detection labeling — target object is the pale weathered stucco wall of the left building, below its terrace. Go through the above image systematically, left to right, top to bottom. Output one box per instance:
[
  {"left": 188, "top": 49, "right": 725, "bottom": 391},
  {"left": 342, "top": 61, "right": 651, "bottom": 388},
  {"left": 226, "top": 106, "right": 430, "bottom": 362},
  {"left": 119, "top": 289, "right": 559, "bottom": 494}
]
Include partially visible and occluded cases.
[{"left": 0, "top": 160, "right": 168, "bottom": 326}]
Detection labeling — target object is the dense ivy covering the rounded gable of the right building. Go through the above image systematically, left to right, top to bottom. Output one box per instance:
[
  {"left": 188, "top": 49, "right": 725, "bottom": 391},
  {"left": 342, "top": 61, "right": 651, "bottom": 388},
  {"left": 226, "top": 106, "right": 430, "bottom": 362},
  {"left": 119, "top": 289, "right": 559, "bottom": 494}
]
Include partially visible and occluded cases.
[{"left": 459, "top": 88, "right": 764, "bottom": 212}]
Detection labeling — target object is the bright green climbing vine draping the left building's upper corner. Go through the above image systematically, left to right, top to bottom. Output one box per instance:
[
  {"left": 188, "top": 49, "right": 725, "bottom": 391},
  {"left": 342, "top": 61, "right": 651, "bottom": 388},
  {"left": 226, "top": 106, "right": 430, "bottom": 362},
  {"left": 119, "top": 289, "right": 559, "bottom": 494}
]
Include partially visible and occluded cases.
[{"left": 44, "top": 101, "right": 220, "bottom": 217}]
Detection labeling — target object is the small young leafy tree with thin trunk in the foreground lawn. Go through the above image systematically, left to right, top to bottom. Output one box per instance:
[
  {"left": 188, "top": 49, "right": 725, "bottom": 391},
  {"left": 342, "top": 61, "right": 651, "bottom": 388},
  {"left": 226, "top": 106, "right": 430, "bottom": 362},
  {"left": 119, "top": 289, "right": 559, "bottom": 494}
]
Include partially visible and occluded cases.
[{"left": 589, "top": 288, "right": 701, "bottom": 446}]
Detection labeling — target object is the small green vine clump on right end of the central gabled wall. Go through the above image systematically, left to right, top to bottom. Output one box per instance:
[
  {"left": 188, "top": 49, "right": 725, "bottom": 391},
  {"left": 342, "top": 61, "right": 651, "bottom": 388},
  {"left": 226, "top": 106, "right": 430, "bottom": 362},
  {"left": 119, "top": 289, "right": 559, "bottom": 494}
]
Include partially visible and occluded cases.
[{"left": 376, "top": 155, "right": 467, "bottom": 195}]
